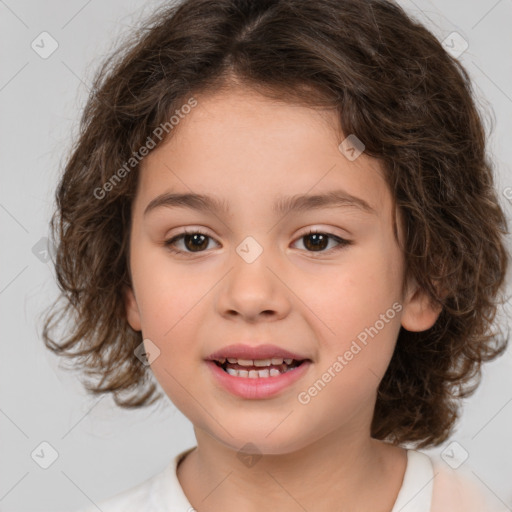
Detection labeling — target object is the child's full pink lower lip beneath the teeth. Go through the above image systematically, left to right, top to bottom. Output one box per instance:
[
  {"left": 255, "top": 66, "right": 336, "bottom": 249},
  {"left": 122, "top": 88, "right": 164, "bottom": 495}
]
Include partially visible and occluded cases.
[{"left": 206, "top": 361, "right": 311, "bottom": 399}]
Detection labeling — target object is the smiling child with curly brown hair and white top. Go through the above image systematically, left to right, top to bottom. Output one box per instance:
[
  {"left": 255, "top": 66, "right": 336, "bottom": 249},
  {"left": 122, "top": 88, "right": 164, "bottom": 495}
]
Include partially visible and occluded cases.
[{"left": 44, "top": 0, "right": 508, "bottom": 512}]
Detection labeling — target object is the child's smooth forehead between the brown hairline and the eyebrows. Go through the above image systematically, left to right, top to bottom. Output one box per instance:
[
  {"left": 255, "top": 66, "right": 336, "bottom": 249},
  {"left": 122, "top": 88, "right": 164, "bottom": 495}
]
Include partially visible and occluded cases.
[{"left": 137, "top": 85, "right": 390, "bottom": 216}]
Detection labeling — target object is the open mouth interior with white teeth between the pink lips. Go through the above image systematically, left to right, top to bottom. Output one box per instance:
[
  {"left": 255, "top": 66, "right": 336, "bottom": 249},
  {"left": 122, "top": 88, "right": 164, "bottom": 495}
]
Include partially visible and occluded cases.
[{"left": 211, "top": 357, "right": 311, "bottom": 379}]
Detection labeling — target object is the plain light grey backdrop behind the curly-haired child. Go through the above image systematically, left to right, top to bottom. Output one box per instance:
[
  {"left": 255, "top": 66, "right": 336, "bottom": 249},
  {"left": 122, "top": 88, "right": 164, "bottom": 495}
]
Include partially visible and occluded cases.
[{"left": 0, "top": 0, "right": 512, "bottom": 512}]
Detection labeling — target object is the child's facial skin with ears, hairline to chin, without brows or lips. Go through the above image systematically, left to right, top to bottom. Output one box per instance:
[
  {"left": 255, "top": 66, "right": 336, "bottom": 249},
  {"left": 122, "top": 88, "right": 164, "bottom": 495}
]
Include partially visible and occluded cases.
[{"left": 127, "top": 86, "right": 438, "bottom": 453}]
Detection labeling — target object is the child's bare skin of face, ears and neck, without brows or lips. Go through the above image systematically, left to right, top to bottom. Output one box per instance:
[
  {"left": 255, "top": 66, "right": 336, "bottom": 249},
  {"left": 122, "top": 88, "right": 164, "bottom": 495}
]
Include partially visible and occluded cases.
[{"left": 126, "top": 87, "right": 439, "bottom": 512}]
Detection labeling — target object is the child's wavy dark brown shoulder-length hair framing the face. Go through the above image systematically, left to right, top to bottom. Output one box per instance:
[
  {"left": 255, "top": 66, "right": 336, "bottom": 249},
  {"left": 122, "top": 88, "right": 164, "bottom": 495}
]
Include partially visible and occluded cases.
[{"left": 43, "top": 0, "right": 508, "bottom": 448}]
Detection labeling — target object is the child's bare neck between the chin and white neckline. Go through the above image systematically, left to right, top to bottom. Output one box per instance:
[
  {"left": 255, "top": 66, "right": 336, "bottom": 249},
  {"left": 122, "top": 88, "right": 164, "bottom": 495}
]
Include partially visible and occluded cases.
[{"left": 177, "top": 428, "right": 406, "bottom": 512}]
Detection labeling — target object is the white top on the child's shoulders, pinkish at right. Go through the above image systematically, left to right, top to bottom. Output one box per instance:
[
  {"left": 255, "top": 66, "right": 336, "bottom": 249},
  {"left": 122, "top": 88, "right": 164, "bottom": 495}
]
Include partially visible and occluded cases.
[{"left": 79, "top": 447, "right": 510, "bottom": 512}]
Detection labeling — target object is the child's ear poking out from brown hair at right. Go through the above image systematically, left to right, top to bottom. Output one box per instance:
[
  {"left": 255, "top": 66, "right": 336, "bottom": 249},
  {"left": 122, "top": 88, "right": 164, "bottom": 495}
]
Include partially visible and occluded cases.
[{"left": 401, "top": 281, "right": 443, "bottom": 332}]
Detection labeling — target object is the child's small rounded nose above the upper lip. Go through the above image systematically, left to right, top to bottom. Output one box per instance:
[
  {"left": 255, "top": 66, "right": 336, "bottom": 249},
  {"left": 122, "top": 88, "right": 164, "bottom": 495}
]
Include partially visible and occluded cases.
[{"left": 216, "top": 246, "right": 292, "bottom": 323}]
